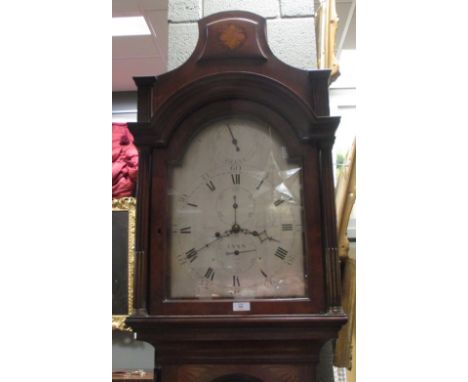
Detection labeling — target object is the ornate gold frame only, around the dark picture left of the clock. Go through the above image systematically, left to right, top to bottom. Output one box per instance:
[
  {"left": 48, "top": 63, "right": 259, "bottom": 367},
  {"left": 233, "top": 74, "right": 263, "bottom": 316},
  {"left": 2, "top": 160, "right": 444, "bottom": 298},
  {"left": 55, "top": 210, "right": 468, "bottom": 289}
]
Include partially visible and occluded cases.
[{"left": 112, "top": 197, "right": 136, "bottom": 331}]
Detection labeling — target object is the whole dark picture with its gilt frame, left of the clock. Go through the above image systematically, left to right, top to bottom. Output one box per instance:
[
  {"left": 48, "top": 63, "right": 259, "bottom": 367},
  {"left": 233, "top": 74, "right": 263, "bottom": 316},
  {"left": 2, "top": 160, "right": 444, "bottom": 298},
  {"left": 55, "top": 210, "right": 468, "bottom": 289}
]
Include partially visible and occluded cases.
[{"left": 112, "top": 197, "right": 136, "bottom": 331}]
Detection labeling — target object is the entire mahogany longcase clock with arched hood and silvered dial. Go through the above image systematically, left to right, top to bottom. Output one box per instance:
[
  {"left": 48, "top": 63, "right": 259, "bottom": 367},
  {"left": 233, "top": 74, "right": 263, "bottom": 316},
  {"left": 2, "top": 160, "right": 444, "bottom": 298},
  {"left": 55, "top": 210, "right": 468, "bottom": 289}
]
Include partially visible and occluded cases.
[{"left": 127, "top": 12, "right": 346, "bottom": 382}]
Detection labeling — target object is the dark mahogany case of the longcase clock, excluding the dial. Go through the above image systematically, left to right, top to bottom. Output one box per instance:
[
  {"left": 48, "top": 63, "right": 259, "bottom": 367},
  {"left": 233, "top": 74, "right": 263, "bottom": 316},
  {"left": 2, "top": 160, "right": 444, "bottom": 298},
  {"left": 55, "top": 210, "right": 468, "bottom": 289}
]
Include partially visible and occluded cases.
[{"left": 126, "top": 11, "right": 346, "bottom": 382}]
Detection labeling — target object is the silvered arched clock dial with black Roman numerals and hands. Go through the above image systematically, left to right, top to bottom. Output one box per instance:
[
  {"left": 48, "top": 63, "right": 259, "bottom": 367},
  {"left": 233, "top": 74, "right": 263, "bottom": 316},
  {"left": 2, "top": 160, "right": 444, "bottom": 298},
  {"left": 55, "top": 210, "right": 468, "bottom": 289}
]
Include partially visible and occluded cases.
[{"left": 168, "top": 117, "right": 308, "bottom": 299}]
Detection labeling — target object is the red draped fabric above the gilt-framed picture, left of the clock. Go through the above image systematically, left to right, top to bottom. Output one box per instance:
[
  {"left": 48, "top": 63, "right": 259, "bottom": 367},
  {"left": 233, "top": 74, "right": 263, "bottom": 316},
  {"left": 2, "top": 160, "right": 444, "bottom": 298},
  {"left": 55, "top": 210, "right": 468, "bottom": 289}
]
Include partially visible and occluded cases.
[{"left": 112, "top": 123, "right": 138, "bottom": 198}]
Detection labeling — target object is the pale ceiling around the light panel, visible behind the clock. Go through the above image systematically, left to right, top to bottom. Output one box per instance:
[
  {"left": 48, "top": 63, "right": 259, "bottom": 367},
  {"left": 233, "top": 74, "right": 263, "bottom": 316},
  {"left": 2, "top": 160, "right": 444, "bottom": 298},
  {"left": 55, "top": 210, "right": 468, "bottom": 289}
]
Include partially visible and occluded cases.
[{"left": 112, "top": 0, "right": 356, "bottom": 92}]
